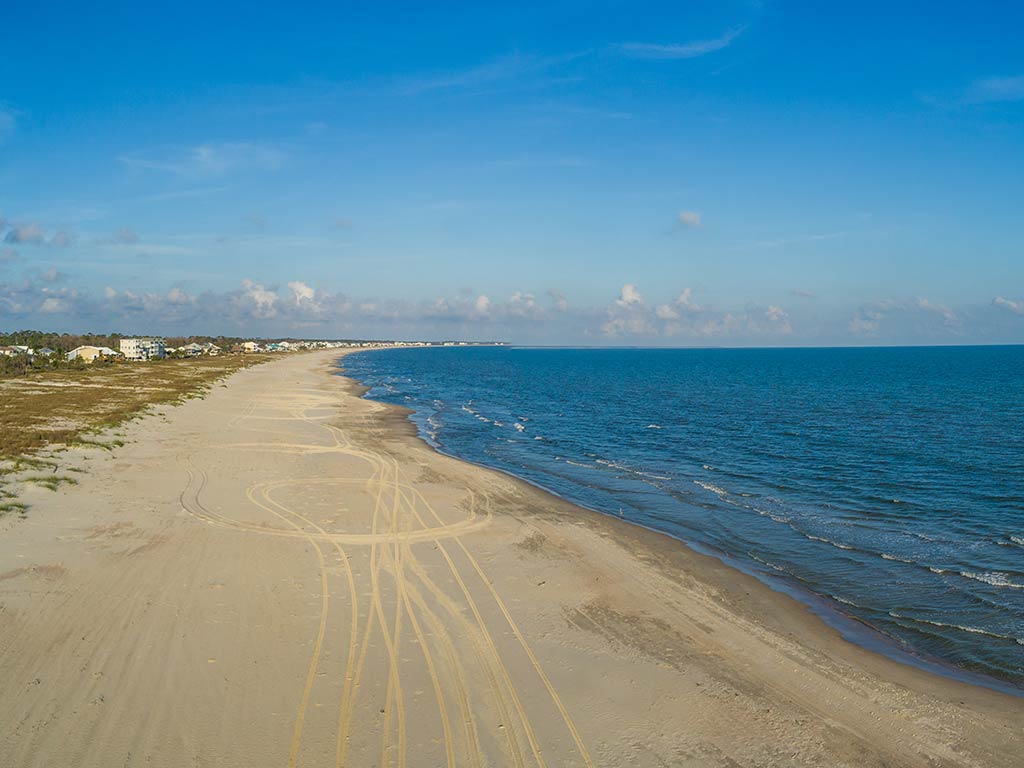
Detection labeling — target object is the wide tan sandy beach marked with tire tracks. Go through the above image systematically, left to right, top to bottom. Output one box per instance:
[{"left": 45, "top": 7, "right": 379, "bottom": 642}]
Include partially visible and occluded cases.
[{"left": 0, "top": 350, "right": 1024, "bottom": 768}]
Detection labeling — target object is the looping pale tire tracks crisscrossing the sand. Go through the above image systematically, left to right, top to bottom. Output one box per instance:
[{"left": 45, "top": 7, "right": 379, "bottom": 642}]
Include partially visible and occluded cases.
[{"left": 181, "top": 376, "right": 594, "bottom": 768}]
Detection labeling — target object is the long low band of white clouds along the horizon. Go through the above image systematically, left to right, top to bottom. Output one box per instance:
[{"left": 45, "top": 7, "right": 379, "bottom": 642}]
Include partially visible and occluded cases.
[{"left": 0, "top": 268, "right": 1007, "bottom": 345}]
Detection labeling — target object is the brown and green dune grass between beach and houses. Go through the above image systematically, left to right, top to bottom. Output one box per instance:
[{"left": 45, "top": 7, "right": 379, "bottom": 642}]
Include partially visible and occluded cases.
[{"left": 0, "top": 354, "right": 271, "bottom": 462}]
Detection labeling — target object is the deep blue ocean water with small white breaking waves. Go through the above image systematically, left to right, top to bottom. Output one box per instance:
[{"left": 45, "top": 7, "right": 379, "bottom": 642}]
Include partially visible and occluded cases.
[{"left": 344, "top": 347, "right": 1024, "bottom": 686}]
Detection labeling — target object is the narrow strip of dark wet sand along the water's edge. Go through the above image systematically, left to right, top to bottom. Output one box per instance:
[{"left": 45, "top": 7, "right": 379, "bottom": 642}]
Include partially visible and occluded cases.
[{"left": 336, "top": 349, "right": 1024, "bottom": 698}]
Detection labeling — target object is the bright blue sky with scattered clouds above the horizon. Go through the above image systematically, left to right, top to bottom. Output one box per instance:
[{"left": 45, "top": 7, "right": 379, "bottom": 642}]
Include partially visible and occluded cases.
[{"left": 0, "top": 0, "right": 1024, "bottom": 346}]
